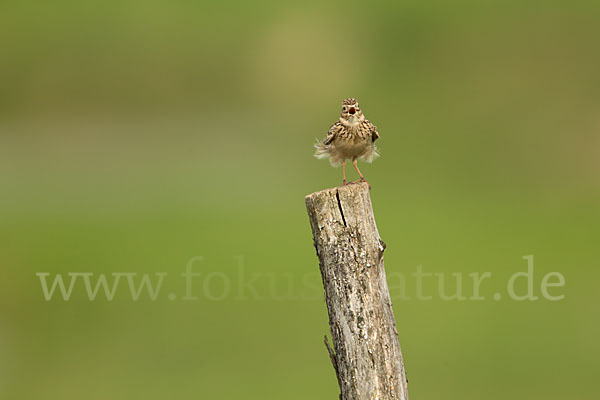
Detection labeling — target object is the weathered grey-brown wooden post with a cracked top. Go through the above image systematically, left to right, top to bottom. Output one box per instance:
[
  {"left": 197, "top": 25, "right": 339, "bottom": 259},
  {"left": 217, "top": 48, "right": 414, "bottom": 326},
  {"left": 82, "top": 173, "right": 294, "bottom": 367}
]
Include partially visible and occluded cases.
[{"left": 306, "top": 183, "right": 408, "bottom": 400}]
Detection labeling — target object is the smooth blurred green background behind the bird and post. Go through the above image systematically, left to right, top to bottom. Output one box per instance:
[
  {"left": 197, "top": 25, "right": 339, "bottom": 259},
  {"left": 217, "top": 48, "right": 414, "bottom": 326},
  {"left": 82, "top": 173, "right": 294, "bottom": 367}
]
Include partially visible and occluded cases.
[{"left": 0, "top": 0, "right": 600, "bottom": 400}]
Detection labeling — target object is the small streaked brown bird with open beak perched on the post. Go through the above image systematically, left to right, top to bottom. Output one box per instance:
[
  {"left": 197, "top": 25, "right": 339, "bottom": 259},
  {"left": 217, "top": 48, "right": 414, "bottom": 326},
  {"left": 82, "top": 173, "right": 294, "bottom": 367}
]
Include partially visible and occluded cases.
[{"left": 315, "top": 99, "right": 379, "bottom": 185}]
